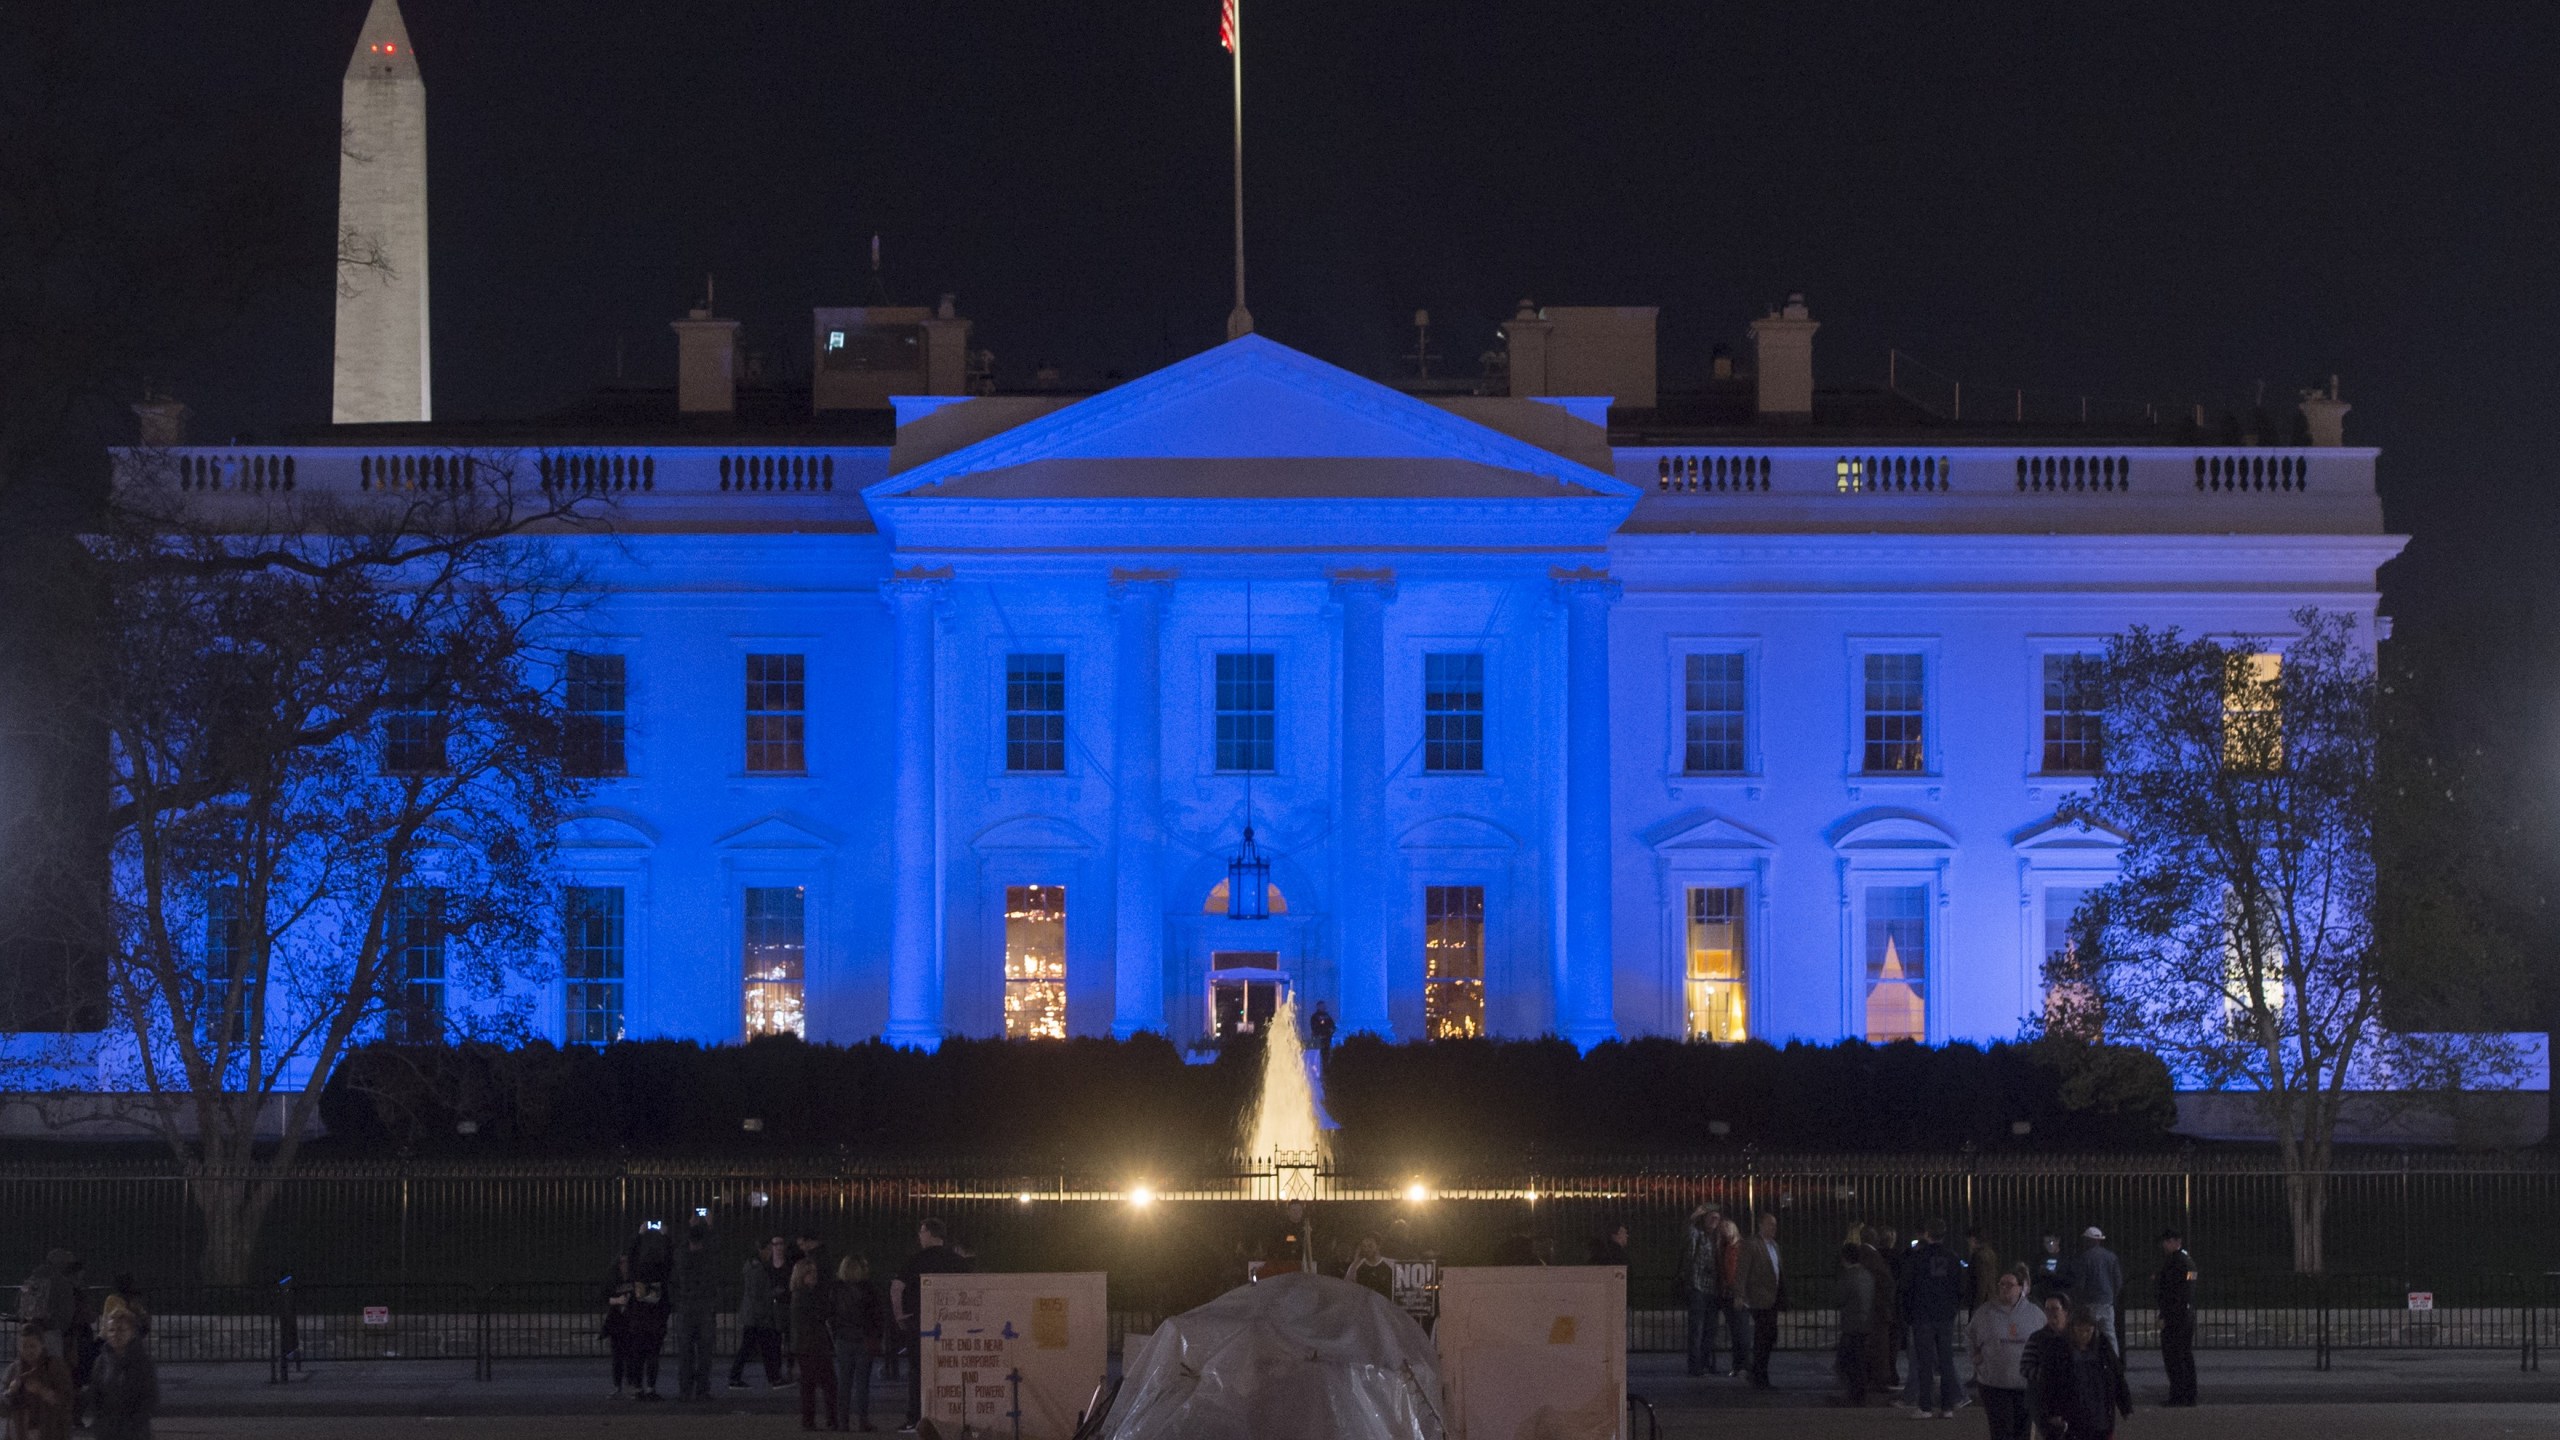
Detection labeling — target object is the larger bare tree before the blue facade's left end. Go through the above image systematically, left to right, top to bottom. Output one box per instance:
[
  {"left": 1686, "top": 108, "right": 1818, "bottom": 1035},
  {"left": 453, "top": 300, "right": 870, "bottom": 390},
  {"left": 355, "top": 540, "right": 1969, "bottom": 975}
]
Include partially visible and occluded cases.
[{"left": 13, "top": 454, "right": 593, "bottom": 1281}]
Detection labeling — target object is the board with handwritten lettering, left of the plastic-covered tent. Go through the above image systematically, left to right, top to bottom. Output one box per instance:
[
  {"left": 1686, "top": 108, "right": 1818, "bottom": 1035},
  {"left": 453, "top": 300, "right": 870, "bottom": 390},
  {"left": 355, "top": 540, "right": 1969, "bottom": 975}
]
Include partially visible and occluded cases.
[{"left": 916, "top": 1271, "right": 1111, "bottom": 1440}]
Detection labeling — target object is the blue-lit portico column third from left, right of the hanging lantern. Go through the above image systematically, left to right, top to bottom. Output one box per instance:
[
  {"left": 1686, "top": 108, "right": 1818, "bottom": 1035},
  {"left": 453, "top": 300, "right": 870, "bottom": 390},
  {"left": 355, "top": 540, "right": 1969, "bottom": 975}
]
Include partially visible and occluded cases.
[{"left": 1334, "top": 569, "right": 1395, "bottom": 1040}]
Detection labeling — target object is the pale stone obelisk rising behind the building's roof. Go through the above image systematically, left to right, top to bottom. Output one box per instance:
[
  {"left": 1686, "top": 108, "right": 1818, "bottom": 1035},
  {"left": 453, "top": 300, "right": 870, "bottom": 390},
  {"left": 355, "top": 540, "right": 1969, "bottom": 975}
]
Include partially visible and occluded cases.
[{"left": 330, "top": 0, "right": 433, "bottom": 425}]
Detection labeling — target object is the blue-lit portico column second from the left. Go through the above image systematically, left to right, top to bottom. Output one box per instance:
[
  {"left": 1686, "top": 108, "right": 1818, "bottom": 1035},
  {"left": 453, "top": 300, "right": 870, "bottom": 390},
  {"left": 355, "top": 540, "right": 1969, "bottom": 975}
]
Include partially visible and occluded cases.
[{"left": 1111, "top": 569, "right": 1172, "bottom": 1040}]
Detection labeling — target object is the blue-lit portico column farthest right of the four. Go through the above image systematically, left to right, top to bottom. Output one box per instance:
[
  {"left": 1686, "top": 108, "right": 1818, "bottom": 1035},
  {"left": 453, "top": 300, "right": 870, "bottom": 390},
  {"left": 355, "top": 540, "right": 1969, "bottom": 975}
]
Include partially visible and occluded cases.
[{"left": 1554, "top": 569, "right": 1618, "bottom": 1051}]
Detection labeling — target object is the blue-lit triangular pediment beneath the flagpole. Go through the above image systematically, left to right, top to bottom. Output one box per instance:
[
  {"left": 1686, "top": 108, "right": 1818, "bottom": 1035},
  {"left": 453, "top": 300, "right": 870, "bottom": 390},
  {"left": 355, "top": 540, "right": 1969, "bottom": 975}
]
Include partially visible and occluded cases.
[{"left": 863, "top": 336, "right": 1636, "bottom": 502}]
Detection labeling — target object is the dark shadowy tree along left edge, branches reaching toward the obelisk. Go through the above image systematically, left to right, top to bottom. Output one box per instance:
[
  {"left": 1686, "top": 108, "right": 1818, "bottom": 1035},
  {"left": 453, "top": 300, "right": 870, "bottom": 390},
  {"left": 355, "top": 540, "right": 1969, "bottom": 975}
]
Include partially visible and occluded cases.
[{"left": 0, "top": 3, "right": 389, "bottom": 1030}]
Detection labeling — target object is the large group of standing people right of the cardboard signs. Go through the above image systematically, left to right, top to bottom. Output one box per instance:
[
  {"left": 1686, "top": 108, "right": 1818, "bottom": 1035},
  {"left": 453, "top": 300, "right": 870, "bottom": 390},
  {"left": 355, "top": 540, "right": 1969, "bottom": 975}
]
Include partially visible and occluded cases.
[{"left": 1822, "top": 1220, "right": 2196, "bottom": 1440}]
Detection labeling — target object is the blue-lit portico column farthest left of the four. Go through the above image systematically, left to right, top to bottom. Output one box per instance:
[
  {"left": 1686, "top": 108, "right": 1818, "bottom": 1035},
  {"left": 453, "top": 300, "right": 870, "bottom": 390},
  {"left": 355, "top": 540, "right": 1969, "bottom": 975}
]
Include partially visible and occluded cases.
[{"left": 881, "top": 569, "right": 950, "bottom": 1051}]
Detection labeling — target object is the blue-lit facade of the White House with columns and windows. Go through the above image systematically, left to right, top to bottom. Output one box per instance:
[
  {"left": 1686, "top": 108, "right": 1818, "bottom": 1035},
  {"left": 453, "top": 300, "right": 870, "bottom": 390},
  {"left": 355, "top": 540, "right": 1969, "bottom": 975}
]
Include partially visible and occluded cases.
[{"left": 154, "top": 336, "right": 2401, "bottom": 1045}]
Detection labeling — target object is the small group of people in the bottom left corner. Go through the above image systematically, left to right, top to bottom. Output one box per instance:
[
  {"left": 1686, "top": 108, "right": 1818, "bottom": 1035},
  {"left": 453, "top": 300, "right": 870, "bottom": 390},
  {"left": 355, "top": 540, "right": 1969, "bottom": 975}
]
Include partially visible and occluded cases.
[{"left": 0, "top": 1250, "right": 159, "bottom": 1440}]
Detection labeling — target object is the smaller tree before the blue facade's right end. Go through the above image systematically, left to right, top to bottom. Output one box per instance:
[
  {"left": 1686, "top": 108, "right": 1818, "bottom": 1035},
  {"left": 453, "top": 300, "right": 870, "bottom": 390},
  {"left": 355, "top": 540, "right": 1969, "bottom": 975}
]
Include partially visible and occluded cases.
[{"left": 2045, "top": 610, "right": 2516, "bottom": 1273}]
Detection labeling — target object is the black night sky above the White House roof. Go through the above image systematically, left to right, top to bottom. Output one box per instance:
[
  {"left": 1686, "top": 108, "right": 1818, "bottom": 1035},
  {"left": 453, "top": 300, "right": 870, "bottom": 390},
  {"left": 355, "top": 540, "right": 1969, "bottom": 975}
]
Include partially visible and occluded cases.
[{"left": 100, "top": 0, "right": 2560, "bottom": 589}]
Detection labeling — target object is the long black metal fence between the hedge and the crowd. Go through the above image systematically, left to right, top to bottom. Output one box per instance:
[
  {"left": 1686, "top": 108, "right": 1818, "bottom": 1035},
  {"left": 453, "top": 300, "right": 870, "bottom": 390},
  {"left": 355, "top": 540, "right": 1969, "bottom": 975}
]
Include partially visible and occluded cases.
[{"left": 0, "top": 1150, "right": 2560, "bottom": 1358}]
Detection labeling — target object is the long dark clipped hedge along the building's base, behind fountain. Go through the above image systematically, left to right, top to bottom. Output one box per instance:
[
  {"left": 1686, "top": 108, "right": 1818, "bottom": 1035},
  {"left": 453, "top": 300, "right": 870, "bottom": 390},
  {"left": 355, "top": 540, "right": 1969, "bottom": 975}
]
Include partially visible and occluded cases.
[{"left": 320, "top": 1035, "right": 2176, "bottom": 1153}]
